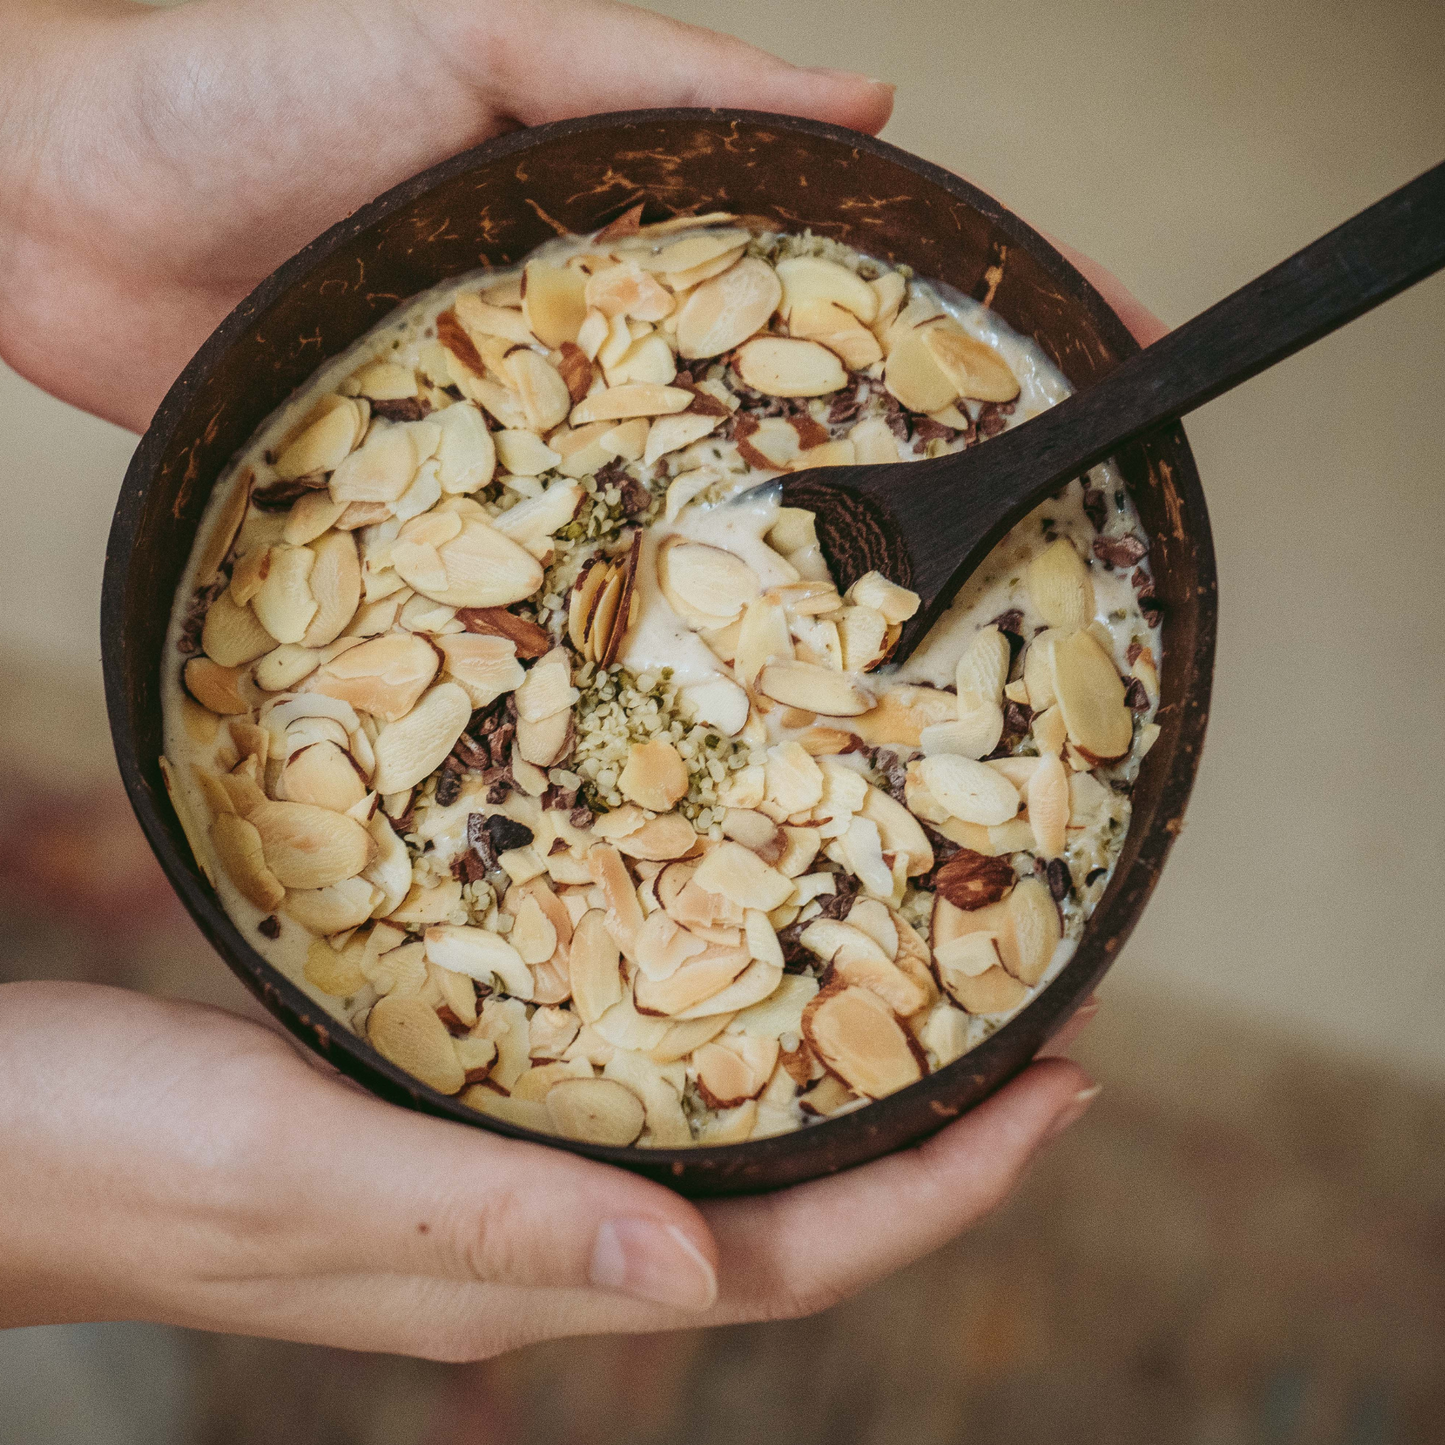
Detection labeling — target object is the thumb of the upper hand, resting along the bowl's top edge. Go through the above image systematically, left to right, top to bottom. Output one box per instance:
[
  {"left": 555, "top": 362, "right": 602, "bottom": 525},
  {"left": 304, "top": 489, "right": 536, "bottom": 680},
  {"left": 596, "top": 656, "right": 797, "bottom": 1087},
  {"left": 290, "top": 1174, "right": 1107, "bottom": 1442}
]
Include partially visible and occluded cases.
[{"left": 442, "top": 0, "right": 893, "bottom": 134}]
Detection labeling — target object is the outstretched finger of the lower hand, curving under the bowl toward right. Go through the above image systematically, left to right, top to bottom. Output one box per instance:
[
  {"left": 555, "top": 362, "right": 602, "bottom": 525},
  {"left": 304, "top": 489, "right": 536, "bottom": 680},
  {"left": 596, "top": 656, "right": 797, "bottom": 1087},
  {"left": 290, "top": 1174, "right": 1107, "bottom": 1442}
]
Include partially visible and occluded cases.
[{"left": 704, "top": 1059, "right": 1097, "bottom": 1319}]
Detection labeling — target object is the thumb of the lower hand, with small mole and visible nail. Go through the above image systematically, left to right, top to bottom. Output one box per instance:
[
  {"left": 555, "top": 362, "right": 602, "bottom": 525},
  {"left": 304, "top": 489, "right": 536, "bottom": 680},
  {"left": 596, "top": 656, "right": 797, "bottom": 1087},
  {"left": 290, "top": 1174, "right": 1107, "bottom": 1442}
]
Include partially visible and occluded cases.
[{"left": 245, "top": 1071, "right": 717, "bottom": 1311}]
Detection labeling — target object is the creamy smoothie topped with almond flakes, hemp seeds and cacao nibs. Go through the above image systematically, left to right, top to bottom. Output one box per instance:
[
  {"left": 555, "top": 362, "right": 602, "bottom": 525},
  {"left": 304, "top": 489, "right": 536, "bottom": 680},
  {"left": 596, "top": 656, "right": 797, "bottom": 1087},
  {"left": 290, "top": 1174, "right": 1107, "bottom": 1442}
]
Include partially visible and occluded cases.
[{"left": 162, "top": 207, "right": 1159, "bottom": 1147}]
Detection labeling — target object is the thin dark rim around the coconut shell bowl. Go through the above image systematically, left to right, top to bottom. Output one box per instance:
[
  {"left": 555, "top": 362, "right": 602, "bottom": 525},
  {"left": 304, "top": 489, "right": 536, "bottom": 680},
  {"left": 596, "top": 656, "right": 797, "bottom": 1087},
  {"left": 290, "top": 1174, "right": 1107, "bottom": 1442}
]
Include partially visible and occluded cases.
[{"left": 100, "top": 107, "right": 1217, "bottom": 1194}]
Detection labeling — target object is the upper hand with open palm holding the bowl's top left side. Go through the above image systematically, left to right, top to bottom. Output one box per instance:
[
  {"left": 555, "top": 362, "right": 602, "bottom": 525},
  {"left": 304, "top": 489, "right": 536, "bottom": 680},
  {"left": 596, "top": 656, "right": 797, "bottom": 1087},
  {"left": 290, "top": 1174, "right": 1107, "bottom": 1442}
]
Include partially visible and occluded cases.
[{"left": 0, "top": 0, "right": 893, "bottom": 431}]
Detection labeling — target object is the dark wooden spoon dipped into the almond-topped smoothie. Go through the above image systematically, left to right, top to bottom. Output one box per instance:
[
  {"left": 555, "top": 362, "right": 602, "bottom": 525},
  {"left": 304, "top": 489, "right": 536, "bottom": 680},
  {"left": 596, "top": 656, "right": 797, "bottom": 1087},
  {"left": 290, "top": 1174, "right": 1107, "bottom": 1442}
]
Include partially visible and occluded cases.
[{"left": 783, "top": 163, "right": 1445, "bottom": 662}]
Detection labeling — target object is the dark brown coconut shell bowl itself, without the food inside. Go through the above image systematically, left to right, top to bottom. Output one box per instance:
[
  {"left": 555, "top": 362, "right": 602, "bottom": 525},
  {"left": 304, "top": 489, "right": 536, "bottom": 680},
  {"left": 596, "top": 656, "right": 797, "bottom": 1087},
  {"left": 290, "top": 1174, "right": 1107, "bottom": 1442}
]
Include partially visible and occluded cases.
[{"left": 101, "top": 110, "right": 1215, "bottom": 1195}]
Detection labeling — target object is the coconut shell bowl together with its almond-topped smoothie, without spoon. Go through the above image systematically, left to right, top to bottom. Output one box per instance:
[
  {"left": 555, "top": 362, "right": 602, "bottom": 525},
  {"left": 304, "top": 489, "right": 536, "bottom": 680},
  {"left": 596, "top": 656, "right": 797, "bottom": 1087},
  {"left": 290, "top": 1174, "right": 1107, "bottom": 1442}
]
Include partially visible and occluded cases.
[{"left": 104, "top": 111, "right": 1214, "bottom": 1194}]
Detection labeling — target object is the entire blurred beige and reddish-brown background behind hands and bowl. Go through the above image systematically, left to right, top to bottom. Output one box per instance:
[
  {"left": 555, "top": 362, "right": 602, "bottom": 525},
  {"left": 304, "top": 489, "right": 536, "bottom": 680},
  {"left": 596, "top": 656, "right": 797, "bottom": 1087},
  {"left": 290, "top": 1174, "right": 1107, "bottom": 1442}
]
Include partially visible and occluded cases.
[{"left": 0, "top": 0, "right": 1445, "bottom": 1445}]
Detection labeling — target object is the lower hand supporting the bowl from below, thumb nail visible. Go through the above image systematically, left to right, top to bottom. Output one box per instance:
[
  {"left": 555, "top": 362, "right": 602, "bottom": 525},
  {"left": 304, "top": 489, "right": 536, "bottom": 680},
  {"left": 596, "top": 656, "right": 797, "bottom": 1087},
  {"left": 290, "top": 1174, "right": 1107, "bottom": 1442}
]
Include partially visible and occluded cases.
[{"left": 0, "top": 984, "right": 1094, "bottom": 1360}]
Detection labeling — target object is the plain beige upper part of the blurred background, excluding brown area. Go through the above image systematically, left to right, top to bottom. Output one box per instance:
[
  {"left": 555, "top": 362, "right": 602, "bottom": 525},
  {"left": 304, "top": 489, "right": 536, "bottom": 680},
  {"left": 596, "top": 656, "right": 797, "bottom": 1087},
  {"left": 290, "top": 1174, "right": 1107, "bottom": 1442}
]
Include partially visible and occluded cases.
[{"left": 0, "top": 0, "right": 1445, "bottom": 1082}]
